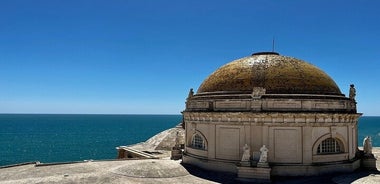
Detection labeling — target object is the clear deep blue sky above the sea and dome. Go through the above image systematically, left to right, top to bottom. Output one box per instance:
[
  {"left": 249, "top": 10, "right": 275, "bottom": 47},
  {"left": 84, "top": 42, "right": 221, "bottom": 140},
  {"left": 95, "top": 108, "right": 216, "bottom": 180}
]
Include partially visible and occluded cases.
[{"left": 0, "top": 0, "right": 380, "bottom": 115}]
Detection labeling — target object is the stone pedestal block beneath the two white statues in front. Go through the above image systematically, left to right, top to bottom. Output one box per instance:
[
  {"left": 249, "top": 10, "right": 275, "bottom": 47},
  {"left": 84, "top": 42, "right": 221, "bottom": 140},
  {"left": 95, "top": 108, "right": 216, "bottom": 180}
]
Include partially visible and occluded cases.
[{"left": 237, "top": 167, "right": 271, "bottom": 183}]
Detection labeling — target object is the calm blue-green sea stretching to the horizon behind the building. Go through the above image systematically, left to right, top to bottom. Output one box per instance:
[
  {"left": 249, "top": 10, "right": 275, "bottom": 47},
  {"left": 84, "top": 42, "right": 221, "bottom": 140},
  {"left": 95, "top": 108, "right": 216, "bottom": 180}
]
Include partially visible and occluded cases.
[{"left": 0, "top": 114, "right": 380, "bottom": 166}]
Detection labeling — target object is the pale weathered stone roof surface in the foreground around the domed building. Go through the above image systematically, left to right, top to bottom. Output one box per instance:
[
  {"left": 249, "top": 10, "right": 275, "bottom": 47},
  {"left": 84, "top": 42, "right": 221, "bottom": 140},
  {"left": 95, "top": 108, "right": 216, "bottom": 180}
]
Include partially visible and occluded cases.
[{"left": 0, "top": 138, "right": 380, "bottom": 184}]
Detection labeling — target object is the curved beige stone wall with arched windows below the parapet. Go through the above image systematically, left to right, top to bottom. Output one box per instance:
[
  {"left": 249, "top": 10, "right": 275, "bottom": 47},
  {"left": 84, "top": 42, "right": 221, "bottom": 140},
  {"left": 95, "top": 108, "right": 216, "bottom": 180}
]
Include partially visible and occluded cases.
[{"left": 183, "top": 112, "right": 360, "bottom": 175}]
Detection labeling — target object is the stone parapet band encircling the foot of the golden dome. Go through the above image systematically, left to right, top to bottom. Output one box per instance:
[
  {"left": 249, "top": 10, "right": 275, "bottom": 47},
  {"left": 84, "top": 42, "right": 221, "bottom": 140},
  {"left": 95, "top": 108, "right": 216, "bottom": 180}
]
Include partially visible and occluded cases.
[{"left": 185, "top": 96, "right": 356, "bottom": 113}]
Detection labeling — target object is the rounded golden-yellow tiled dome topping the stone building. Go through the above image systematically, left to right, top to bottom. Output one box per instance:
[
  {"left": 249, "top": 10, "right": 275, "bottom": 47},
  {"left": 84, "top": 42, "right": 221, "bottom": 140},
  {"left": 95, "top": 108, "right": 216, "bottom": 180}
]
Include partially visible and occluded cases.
[{"left": 197, "top": 52, "right": 342, "bottom": 95}]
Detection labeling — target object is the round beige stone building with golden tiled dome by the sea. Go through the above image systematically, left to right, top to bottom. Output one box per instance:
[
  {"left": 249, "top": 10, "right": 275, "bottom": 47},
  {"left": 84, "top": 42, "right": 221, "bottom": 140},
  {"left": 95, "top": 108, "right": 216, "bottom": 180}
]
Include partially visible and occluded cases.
[{"left": 183, "top": 52, "right": 361, "bottom": 176}]
